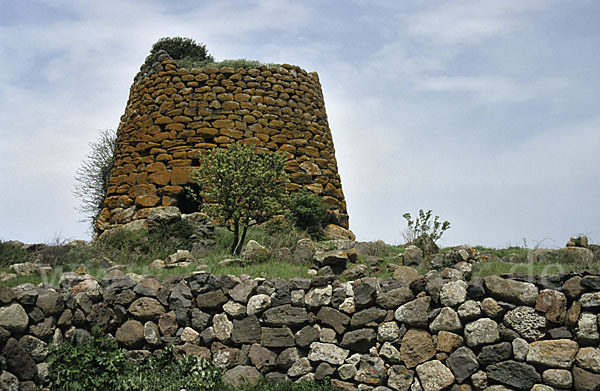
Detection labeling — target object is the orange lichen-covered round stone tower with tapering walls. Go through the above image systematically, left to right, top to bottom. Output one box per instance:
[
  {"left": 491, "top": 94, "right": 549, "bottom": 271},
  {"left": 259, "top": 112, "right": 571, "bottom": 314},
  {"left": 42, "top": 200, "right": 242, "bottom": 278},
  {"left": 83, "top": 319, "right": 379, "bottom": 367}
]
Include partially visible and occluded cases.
[{"left": 98, "top": 53, "right": 348, "bottom": 236}]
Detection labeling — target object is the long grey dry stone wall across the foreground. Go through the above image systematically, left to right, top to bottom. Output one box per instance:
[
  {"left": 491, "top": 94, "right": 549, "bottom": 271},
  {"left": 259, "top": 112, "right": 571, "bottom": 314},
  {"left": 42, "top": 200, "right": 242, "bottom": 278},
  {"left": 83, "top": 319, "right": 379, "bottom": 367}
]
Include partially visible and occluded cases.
[{"left": 0, "top": 272, "right": 600, "bottom": 391}]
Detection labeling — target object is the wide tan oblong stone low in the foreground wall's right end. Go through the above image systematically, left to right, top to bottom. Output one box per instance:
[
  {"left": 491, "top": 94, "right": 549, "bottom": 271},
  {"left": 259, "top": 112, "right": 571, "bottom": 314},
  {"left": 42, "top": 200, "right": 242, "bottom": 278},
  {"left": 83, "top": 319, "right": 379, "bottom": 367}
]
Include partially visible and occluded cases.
[{"left": 527, "top": 339, "right": 579, "bottom": 369}]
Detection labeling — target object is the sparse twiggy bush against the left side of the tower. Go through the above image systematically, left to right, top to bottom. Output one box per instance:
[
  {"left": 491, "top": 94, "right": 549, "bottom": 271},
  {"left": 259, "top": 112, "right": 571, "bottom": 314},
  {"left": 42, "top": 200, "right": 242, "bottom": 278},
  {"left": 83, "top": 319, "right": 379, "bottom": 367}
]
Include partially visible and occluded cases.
[{"left": 73, "top": 129, "right": 117, "bottom": 232}]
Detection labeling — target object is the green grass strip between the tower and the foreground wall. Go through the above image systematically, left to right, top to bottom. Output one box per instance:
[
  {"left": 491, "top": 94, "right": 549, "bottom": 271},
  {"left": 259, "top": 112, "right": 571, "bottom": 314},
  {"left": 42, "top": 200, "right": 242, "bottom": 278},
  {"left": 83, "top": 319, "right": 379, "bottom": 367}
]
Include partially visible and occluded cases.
[{"left": 0, "top": 225, "right": 600, "bottom": 286}]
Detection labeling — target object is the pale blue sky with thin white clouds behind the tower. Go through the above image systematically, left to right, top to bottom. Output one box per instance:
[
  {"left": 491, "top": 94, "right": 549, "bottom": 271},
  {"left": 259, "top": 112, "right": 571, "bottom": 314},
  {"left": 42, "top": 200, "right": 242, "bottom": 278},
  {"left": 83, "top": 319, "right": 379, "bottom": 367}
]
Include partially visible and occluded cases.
[{"left": 0, "top": 0, "right": 600, "bottom": 248}]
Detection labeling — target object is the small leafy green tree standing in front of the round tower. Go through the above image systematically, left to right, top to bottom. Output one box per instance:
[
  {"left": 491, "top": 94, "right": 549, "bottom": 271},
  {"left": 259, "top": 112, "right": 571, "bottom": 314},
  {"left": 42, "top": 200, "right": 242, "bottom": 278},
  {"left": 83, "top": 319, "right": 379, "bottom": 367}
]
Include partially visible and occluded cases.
[{"left": 188, "top": 143, "right": 287, "bottom": 255}]
